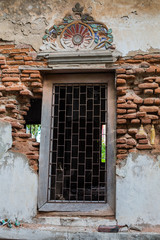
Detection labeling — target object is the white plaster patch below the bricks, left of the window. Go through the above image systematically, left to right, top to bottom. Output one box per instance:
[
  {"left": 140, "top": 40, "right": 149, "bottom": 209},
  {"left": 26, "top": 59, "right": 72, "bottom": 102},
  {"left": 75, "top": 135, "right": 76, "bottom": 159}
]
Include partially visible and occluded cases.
[{"left": 0, "top": 121, "right": 38, "bottom": 221}]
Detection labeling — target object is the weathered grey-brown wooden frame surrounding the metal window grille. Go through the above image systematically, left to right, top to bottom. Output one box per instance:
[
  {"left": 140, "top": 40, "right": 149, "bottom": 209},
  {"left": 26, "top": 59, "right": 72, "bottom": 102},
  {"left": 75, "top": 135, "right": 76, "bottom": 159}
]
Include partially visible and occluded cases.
[{"left": 38, "top": 72, "right": 116, "bottom": 216}]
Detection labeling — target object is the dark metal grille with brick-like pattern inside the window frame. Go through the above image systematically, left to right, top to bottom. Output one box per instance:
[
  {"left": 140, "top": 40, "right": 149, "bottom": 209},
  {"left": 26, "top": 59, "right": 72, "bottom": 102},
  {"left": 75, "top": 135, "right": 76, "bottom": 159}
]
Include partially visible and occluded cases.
[{"left": 48, "top": 84, "right": 107, "bottom": 203}]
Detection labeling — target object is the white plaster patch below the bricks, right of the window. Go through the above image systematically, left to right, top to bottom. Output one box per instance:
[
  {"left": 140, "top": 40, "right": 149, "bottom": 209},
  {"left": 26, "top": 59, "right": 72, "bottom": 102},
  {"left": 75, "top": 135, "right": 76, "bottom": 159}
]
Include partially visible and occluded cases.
[{"left": 116, "top": 154, "right": 160, "bottom": 225}]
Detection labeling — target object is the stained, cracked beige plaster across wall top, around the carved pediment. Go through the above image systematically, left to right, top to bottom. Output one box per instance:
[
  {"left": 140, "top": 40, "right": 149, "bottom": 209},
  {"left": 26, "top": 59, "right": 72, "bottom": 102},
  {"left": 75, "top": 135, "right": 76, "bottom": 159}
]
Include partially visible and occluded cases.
[{"left": 0, "top": 0, "right": 160, "bottom": 56}]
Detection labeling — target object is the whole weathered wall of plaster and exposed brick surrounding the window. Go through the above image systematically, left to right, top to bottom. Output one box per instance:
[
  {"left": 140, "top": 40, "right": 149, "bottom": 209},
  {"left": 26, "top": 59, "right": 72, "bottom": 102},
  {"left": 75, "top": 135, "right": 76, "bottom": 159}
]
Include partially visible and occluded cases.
[{"left": 0, "top": 0, "right": 160, "bottom": 224}]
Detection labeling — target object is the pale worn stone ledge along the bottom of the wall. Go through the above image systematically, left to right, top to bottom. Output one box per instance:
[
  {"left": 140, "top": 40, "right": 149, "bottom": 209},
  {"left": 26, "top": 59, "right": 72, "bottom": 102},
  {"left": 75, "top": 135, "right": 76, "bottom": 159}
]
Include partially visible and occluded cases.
[{"left": 0, "top": 225, "right": 160, "bottom": 240}]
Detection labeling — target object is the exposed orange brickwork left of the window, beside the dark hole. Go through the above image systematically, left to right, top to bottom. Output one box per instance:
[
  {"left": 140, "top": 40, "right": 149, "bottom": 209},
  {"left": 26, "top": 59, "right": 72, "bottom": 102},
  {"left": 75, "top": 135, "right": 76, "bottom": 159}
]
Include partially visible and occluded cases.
[{"left": 0, "top": 42, "right": 46, "bottom": 171}]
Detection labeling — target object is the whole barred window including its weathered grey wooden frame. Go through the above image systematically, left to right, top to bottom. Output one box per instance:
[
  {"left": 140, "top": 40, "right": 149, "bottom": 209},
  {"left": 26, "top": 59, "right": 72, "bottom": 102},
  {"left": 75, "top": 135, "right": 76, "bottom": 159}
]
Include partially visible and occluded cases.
[{"left": 39, "top": 73, "right": 115, "bottom": 212}]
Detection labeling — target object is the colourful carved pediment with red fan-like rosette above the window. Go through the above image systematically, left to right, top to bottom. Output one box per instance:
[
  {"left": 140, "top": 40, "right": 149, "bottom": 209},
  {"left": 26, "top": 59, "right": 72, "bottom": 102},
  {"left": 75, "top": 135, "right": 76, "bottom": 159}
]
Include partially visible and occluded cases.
[{"left": 40, "top": 3, "right": 113, "bottom": 52}]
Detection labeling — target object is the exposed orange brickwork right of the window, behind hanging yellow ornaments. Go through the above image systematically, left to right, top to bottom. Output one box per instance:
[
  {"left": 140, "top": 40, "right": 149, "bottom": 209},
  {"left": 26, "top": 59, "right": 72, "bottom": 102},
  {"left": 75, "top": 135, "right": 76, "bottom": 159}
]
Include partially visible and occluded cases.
[{"left": 116, "top": 54, "right": 160, "bottom": 163}]
